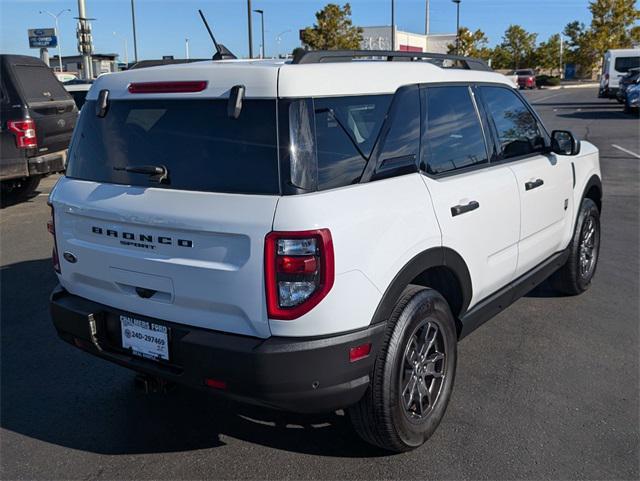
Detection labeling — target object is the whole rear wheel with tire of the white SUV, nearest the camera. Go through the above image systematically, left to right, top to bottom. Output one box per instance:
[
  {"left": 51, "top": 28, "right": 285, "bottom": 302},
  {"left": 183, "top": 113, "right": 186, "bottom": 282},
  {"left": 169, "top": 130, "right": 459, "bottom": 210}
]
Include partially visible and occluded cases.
[{"left": 349, "top": 286, "right": 458, "bottom": 452}]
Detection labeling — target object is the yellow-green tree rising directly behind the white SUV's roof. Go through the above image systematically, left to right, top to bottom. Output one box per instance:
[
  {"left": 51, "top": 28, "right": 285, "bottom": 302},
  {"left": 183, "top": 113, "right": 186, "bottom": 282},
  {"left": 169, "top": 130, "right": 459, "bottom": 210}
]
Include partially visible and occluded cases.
[{"left": 301, "top": 3, "right": 362, "bottom": 50}]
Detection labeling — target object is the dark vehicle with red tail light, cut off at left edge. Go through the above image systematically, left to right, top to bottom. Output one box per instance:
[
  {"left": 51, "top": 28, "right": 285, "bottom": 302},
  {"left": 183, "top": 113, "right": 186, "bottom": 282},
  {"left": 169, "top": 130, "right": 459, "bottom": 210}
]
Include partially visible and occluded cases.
[{"left": 0, "top": 55, "right": 78, "bottom": 200}]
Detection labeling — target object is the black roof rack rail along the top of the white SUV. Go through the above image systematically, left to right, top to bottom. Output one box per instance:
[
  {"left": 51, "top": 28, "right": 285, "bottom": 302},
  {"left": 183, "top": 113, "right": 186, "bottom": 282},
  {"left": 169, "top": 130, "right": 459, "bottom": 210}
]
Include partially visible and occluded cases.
[{"left": 291, "top": 50, "right": 492, "bottom": 72}]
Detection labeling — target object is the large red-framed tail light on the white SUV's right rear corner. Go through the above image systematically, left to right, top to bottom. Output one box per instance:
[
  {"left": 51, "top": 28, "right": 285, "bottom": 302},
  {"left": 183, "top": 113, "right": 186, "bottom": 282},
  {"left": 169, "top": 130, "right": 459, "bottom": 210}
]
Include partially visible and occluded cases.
[{"left": 265, "top": 229, "right": 335, "bottom": 320}]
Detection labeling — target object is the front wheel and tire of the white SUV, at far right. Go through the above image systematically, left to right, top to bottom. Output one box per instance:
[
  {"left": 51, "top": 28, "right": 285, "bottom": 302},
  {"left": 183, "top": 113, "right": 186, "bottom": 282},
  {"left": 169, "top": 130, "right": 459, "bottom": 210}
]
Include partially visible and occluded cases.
[{"left": 551, "top": 199, "right": 600, "bottom": 296}]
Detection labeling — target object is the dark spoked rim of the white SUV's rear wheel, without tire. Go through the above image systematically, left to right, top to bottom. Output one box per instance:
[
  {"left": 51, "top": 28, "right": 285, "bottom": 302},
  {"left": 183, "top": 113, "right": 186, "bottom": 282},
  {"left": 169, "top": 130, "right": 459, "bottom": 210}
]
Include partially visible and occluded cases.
[{"left": 400, "top": 320, "right": 446, "bottom": 421}]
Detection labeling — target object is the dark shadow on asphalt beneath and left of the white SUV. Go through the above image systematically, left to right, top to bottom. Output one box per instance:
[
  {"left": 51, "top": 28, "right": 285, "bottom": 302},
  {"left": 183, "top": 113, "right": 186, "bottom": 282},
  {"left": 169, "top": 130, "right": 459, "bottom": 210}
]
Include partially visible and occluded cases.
[{"left": 0, "top": 259, "right": 388, "bottom": 457}]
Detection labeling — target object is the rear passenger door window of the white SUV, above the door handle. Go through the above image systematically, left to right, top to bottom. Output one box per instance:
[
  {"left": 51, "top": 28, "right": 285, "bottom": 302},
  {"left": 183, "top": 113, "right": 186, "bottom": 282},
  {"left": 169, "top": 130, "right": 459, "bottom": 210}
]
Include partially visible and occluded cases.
[{"left": 420, "top": 85, "right": 489, "bottom": 174}]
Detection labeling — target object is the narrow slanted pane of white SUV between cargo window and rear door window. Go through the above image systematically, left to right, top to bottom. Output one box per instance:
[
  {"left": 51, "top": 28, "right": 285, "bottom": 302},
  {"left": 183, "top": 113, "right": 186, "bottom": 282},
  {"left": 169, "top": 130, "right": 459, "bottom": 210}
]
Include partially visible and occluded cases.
[{"left": 378, "top": 86, "right": 420, "bottom": 171}]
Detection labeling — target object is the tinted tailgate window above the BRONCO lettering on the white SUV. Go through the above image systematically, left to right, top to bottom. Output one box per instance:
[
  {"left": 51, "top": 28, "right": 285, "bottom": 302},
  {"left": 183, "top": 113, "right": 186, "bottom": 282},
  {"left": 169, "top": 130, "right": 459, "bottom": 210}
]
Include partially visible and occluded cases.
[{"left": 67, "top": 99, "right": 280, "bottom": 194}]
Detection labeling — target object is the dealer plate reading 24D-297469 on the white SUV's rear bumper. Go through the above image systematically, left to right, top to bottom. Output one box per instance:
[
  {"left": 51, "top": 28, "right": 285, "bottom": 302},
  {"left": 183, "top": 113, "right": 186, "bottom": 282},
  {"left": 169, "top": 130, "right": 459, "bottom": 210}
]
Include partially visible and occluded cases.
[{"left": 118, "top": 314, "right": 171, "bottom": 362}]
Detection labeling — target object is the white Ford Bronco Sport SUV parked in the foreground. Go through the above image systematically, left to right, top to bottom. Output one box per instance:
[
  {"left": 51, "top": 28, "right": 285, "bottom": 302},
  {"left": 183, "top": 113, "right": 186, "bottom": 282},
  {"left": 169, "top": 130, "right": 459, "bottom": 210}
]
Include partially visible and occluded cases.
[{"left": 50, "top": 52, "right": 602, "bottom": 451}]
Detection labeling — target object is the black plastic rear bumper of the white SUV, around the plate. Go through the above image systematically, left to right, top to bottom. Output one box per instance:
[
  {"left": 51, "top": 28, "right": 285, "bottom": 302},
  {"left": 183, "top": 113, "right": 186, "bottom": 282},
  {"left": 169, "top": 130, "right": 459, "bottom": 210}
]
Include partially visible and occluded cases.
[{"left": 51, "top": 287, "right": 385, "bottom": 413}]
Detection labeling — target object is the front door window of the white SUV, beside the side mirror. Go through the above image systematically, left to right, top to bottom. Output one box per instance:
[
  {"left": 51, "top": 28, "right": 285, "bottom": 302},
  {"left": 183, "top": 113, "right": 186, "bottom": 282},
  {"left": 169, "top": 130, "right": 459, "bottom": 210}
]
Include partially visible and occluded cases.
[{"left": 480, "top": 87, "right": 545, "bottom": 159}]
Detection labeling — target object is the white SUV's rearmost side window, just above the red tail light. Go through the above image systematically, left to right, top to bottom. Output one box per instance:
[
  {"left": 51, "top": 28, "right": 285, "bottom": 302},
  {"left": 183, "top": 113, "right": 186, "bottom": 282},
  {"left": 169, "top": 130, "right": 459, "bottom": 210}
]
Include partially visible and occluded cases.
[{"left": 314, "top": 95, "right": 391, "bottom": 190}]
